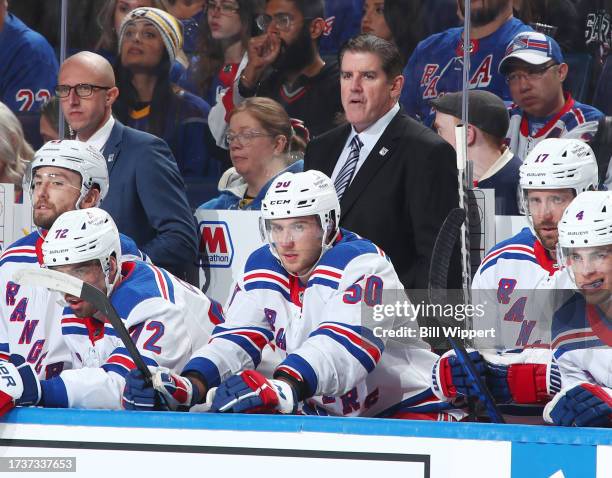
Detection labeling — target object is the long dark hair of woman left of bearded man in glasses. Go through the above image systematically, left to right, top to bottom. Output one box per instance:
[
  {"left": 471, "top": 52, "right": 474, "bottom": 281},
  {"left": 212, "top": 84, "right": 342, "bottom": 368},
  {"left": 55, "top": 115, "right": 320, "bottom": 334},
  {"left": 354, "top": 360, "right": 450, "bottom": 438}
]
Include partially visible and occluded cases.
[{"left": 195, "top": 0, "right": 264, "bottom": 96}]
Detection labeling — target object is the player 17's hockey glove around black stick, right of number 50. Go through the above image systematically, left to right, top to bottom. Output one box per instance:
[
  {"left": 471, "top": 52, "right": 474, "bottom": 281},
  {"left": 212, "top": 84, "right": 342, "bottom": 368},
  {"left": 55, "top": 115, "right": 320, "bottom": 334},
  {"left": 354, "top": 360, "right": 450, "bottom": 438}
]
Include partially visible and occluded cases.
[{"left": 432, "top": 350, "right": 486, "bottom": 399}]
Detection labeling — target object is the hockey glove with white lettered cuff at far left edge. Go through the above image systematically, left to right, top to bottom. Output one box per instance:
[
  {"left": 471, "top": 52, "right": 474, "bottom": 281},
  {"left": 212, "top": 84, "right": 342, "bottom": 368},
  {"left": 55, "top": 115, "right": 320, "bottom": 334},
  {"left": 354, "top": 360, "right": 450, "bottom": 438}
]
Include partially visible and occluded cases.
[{"left": 0, "top": 355, "right": 41, "bottom": 416}]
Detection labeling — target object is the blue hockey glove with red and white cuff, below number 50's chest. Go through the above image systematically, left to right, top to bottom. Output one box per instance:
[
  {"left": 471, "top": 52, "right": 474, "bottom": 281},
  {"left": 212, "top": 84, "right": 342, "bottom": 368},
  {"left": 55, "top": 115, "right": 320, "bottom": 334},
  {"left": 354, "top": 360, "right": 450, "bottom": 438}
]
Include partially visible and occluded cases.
[{"left": 210, "top": 370, "right": 297, "bottom": 413}]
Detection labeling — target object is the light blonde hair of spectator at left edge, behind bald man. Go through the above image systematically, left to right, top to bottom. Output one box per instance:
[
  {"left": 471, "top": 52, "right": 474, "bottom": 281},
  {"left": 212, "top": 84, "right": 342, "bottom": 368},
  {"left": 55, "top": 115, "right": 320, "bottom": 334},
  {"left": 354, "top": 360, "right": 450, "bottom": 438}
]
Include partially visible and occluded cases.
[{"left": 0, "top": 102, "right": 34, "bottom": 191}]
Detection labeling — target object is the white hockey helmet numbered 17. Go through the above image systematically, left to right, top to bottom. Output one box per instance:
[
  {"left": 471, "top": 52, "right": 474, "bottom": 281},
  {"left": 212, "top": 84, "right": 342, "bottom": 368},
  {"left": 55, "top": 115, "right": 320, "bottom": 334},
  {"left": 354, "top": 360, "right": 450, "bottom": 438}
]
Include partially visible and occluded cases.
[{"left": 519, "top": 138, "right": 599, "bottom": 222}]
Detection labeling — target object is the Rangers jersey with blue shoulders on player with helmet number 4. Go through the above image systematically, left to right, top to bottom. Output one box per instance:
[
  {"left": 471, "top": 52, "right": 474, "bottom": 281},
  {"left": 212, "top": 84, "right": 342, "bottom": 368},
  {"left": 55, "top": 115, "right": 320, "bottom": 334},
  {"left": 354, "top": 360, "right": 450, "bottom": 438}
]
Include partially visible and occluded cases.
[{"left": 552, "top": 293, "right": 612, "bottom": 388}]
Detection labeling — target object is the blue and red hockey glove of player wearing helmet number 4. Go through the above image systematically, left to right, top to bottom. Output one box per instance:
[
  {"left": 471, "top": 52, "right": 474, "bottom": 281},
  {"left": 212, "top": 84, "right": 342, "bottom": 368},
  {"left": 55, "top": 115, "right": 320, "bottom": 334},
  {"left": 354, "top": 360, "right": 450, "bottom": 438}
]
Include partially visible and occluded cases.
[{"left": 544, "top": 382, "right": 612, "bottom": 427}]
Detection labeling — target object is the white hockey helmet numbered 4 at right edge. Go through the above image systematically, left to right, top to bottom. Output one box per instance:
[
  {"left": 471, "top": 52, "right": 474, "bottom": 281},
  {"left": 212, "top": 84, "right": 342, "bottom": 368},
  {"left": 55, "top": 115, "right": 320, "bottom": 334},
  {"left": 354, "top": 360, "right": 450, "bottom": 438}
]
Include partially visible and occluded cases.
[{"left": 557, "top": 191, "right": 612, "bottom": 286}]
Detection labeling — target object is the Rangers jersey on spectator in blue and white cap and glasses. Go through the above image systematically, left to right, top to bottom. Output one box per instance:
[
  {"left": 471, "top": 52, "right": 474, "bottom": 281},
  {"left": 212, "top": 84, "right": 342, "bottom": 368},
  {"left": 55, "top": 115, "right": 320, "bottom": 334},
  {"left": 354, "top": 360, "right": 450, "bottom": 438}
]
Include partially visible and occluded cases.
[{"left": 506, "top": 93, "right": 603, "bottom": 158}]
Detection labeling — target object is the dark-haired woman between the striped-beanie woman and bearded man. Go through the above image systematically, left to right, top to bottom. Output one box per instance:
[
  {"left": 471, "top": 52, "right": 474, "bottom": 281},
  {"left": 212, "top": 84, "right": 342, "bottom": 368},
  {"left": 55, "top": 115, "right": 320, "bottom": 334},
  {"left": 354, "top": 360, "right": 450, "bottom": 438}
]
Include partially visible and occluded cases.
[{"left": 179, "top": 0, "right": 265, "bottom": 106}]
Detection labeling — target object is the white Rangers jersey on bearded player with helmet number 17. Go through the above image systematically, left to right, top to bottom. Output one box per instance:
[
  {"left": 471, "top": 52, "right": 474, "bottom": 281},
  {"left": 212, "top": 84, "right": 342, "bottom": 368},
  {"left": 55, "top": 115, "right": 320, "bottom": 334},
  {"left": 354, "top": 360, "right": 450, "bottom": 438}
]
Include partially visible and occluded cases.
[{"left": 472, "top": 227, "right": 558, "bottom": 351}]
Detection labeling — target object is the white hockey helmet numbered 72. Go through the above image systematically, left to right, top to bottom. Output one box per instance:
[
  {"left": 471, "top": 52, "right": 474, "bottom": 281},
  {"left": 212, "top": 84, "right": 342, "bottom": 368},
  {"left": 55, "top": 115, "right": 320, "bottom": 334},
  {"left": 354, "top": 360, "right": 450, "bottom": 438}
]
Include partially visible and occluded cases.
[{"left": 42, "top": 207, "right": 121, "bottom": 295}]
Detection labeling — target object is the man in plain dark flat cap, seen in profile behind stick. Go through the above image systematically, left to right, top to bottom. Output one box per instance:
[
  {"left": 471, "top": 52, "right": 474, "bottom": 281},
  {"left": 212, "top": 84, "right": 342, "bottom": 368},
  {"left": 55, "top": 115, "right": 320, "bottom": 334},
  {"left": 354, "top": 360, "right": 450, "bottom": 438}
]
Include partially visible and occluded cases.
[{"left": 431, "top": 90, "right": 522, "bottom": 216}]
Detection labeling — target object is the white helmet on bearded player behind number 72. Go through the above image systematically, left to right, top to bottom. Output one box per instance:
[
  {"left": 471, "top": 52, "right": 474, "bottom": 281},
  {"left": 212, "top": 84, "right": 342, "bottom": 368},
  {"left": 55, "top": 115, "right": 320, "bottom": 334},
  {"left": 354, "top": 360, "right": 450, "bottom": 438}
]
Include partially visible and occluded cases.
[{"left": 24, "top": 139, "right": 109, "bottom": 209}]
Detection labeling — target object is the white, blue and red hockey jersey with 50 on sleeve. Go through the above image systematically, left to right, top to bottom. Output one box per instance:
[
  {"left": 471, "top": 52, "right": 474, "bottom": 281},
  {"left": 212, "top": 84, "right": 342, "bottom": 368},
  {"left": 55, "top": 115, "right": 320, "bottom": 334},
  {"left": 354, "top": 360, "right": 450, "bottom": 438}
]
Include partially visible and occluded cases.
[{"left": 183, "top": 230, "right": 462, "bottom": 420}]
